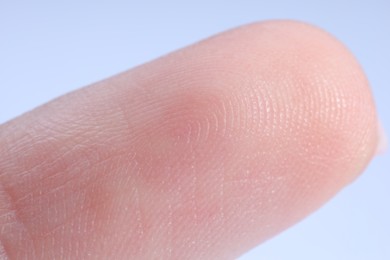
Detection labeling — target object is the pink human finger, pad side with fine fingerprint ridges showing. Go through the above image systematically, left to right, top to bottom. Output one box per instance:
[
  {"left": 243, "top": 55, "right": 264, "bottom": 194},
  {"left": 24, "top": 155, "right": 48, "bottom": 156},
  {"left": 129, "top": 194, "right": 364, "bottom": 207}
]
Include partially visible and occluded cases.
[{"left": 0, "top": 21, "right": 378, "bottom": 259}]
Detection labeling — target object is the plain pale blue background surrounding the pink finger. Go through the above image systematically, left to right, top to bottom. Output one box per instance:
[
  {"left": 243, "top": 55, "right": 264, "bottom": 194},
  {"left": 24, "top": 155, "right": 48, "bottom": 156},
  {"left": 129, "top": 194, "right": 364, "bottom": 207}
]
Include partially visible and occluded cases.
[{"left": 0, "top": 0, "right": 390, "bottom": 260}]
